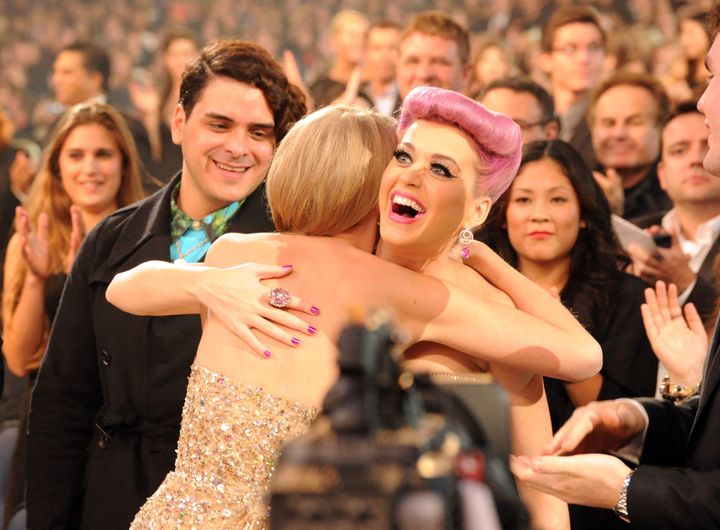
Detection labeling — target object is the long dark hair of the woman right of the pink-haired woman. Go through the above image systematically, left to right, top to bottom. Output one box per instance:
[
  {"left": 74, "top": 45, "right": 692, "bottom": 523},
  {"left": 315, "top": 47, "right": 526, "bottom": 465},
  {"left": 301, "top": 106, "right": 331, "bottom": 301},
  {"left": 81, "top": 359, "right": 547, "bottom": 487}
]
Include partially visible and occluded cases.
[{"left": 476, "top": 140, "right": 629, "bottom": 333}]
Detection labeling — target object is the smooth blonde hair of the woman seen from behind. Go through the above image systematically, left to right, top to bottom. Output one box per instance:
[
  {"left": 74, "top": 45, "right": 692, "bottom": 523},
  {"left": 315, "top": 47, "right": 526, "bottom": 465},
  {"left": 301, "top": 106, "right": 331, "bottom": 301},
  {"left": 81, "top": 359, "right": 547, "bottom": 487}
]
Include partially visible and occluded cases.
[{"left": 266, "top": 106, "right": 397, "bottom": 236}]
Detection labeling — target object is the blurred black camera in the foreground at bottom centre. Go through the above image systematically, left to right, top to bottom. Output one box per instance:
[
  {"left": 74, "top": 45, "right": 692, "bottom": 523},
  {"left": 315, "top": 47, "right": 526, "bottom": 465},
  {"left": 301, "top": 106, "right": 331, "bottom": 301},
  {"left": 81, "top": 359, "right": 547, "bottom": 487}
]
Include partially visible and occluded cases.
[{"left": 270, "top": 312, "right": 529, "bottom": 530}]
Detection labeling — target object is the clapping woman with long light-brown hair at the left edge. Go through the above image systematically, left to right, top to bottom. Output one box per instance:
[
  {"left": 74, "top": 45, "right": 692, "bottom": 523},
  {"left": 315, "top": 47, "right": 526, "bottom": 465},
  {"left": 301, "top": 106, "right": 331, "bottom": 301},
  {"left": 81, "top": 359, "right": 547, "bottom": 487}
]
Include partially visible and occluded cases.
[{"left": 2, "top": 103, "right": 142, "bottom": 523}]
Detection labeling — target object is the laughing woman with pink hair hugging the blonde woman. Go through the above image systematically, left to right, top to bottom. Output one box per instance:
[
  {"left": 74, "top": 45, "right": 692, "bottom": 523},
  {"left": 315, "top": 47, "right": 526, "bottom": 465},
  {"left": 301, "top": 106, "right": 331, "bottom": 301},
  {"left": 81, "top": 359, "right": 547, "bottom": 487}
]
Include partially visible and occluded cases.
[{"left": 378, "top": 87, "right": 569, "bottom": 528}]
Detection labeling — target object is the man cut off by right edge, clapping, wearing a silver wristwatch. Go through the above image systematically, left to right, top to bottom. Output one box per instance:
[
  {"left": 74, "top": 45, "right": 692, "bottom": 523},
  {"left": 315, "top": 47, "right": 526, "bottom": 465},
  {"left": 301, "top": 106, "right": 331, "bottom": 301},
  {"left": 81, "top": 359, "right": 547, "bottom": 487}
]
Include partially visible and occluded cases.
[{"left": 513, "top": 4, "right": 720, "bottom": 530}]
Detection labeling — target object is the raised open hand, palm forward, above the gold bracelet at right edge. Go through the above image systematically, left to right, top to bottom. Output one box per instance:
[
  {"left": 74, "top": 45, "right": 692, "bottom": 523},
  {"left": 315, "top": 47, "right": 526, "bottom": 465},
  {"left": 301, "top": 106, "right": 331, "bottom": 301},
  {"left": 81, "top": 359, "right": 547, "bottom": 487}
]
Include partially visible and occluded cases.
[{"left": 640, "top": 281, "right": 708, "bottom": 386}]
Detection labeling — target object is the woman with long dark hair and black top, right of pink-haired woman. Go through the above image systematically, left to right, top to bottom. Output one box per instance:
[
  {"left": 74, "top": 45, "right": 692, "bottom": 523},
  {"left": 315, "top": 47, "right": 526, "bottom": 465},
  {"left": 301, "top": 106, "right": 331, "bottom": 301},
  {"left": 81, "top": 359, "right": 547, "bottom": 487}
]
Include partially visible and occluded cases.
[{"left": 479, "top": 140, "right": 657, "bottom": 529}]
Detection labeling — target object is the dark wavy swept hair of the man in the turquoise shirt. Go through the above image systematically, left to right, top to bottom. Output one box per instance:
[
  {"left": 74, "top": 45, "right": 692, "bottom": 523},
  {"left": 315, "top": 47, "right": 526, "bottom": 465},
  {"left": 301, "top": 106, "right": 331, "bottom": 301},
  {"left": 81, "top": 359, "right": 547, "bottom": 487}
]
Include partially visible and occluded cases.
[{"left": 180, "top": 39, "right": 307, "bottom": 143}]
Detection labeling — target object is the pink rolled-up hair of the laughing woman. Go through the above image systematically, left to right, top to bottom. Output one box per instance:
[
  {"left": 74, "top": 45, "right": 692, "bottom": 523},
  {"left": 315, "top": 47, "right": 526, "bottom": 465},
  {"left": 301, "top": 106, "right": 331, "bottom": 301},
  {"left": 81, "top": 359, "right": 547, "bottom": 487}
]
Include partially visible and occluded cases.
[{"left": 398, "top": 87, "right": 522, "bottom": 202}]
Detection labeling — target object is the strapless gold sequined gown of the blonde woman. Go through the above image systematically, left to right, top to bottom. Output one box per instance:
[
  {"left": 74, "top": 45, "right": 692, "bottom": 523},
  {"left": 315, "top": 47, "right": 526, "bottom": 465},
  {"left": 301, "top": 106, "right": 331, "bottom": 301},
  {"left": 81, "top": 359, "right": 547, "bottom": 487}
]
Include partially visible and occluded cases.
[{"left": 130, "top": 366, "right": 318, "bottom": 530}]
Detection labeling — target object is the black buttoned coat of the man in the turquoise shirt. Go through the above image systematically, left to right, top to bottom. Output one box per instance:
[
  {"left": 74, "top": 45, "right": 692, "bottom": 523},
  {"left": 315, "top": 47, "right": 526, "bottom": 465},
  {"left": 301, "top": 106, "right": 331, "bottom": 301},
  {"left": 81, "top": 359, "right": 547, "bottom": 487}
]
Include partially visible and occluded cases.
[{"left": 27, "top": 177, "right": 273, "bottom": 530}]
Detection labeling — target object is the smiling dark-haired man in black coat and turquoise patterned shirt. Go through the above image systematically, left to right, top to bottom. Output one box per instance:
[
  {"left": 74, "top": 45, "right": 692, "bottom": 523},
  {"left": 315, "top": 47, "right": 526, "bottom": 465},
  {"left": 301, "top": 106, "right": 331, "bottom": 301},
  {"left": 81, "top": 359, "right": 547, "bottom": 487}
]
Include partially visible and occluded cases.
[{"left": 27, "top": 40, "right": 305, "bottom": 530}]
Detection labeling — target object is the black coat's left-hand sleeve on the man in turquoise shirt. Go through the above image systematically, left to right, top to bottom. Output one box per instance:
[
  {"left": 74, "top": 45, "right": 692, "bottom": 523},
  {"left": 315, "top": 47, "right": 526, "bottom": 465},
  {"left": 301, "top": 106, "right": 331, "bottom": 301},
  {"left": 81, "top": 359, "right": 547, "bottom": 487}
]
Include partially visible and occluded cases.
[{"left": 26, "top": 222, "right": 103, "bottom": 529}]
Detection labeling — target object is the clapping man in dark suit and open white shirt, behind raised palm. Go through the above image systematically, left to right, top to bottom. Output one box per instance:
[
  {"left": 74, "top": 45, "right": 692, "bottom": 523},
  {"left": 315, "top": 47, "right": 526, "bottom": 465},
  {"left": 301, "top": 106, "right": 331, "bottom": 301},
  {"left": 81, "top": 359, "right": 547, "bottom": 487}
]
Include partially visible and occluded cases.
[{"left": 628, "top": 101, "right": 720, "bottom": 326}]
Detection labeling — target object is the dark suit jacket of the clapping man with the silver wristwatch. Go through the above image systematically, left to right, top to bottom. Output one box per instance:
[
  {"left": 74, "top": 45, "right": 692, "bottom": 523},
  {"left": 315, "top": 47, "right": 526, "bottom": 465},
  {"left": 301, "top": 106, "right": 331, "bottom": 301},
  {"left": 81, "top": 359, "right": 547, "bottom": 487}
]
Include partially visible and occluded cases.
[{"left": 628, "top": 316, "right": 720, "bottom": 530}]
